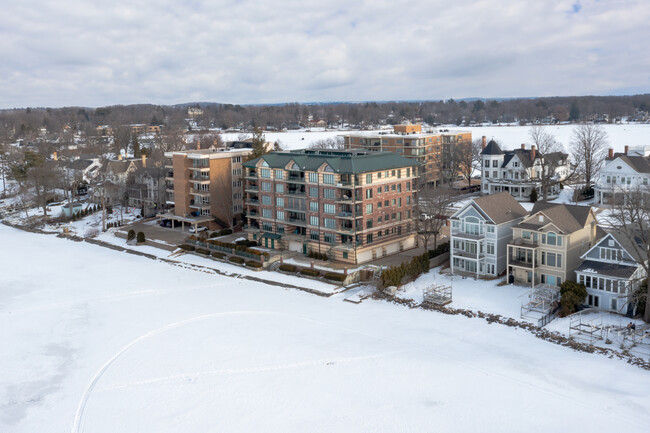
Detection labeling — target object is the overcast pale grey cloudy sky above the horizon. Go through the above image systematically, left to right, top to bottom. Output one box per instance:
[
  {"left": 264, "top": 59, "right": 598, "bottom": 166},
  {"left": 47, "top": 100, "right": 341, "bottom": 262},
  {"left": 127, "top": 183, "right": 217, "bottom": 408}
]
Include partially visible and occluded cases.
[{"left": 0, "top": 0, "right": 650, "bottom": 108}]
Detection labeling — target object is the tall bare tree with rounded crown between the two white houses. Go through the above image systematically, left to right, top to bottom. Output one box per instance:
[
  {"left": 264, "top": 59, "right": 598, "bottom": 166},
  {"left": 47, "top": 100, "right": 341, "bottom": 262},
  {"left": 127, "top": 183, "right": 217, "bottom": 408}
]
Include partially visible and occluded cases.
[{"left": 571, "top": 123, "right": 608, "bottom": 189}]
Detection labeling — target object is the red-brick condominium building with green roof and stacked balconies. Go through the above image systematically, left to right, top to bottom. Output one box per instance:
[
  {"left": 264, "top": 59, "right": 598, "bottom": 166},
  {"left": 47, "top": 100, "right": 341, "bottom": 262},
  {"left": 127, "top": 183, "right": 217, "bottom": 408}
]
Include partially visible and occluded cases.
[{"left": 244, "top": 150, "right": 417, "bottom": 263}]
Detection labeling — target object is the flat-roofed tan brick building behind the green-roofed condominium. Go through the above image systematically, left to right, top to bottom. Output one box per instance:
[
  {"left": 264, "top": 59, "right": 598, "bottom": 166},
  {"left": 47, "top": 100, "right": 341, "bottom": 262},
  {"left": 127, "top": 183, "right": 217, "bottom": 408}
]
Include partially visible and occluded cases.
[{"left": 344, "top": 125, "right": 472, "bottom": 186}]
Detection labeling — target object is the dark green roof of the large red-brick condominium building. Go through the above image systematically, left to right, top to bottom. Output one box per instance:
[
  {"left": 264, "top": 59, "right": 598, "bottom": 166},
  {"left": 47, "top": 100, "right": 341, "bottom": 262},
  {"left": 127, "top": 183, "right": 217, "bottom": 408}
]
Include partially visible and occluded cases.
[{"left": 243, "top": 150, "right": 418, "bottom": 174}]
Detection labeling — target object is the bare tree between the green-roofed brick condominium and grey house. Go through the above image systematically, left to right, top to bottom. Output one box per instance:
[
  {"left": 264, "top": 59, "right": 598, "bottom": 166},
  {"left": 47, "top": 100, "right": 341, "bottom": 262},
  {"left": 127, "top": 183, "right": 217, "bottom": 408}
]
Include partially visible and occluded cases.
[{"left": 415, "top": 184, "right": 456, "bottom": 251}]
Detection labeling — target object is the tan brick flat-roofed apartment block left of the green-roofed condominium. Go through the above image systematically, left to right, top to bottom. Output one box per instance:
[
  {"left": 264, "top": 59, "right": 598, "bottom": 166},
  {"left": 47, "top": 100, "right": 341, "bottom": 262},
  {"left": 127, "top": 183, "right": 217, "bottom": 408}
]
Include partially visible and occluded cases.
[{"left": 165, "top": 149, "right": 253, "bottom": 229}]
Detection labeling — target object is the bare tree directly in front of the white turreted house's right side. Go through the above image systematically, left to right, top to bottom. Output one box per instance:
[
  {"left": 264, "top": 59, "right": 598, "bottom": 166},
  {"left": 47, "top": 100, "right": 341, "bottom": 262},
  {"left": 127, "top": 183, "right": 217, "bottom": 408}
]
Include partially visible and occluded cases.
[{"left": 528, "top": 125, "right": 563, "bottom": 201}]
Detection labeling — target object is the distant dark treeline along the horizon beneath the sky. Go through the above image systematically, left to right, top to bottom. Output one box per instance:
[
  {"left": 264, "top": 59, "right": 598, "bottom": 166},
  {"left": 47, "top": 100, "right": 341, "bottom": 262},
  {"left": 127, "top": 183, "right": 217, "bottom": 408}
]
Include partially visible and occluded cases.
[{"left": 0, "top": 94, "right": 650, "bottom": 139}]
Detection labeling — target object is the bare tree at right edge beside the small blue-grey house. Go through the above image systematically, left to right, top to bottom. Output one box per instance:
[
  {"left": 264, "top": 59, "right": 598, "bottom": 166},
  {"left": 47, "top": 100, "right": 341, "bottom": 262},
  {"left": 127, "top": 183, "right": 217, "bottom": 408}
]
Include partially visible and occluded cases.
[{"left": 609, "top": 187, "right": 650, "bottom": 322}]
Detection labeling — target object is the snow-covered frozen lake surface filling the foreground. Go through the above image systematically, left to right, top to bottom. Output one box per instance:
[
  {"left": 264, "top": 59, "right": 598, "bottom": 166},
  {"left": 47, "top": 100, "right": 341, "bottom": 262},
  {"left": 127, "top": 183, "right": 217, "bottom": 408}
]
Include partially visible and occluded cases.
[{"left": 0, "top": 226, "right": 650, "bottom": 433}]
